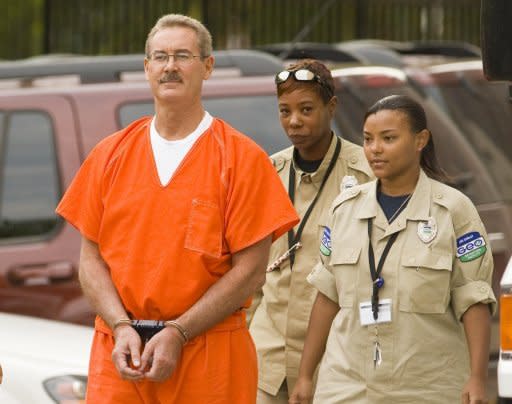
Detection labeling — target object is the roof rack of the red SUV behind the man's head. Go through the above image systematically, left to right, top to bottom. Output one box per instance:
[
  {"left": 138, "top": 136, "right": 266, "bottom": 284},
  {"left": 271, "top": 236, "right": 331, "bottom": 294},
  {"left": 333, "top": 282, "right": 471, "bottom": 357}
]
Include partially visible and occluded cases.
[{"left": 0, "top": 49, "right": 283, "bottom": 84}]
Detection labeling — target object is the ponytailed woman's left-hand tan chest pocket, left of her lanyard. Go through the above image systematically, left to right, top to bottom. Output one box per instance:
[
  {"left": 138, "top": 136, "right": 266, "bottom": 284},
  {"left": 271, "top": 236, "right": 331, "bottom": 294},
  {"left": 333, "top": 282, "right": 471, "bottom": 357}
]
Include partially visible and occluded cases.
[{"left": 330, "top": 247, "right": 361, "bottom": 307}]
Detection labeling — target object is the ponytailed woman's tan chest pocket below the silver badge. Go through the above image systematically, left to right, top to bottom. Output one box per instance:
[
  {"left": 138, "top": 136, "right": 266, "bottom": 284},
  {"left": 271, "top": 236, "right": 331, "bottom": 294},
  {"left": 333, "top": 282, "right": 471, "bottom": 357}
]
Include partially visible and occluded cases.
[{"left": 398, "top": 249, "right": 452, "bottom": 314}]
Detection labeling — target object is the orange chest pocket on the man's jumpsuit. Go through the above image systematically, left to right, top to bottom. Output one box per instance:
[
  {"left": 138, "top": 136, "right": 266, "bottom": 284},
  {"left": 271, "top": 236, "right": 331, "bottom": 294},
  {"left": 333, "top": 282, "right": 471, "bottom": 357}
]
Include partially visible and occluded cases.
[{"left": 185, "top": 199, "right": 222, "bottom": 258}]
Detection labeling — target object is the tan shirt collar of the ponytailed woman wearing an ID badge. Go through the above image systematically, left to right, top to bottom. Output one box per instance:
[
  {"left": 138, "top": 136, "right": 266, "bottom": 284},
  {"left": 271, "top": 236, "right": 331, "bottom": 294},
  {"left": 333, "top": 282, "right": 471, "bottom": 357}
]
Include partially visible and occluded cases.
[{"left": 356, "top": 170, "right": 432, "bottom": 237}]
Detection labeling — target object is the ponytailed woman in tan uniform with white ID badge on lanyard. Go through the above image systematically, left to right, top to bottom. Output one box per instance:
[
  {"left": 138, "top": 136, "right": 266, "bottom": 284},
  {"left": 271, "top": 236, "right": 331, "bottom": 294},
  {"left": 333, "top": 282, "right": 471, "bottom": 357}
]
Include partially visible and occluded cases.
[{"left": 290, "top": 96, "right": 496, "bottom": 404}]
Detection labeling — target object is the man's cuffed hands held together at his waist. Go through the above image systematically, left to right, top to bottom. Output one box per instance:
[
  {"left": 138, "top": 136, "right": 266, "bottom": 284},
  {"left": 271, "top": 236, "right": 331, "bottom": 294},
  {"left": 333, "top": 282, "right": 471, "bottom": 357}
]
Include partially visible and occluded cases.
[{"left": 112, "top": 325, "right": 185, "bottom": 382}]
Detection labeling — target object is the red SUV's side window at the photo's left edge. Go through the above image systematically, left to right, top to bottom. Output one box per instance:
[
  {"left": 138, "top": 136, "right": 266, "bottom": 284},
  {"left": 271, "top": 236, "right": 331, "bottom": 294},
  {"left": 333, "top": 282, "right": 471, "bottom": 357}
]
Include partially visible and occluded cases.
[{"left": 0, "top": 111, "right": 60, "bottom": 243}]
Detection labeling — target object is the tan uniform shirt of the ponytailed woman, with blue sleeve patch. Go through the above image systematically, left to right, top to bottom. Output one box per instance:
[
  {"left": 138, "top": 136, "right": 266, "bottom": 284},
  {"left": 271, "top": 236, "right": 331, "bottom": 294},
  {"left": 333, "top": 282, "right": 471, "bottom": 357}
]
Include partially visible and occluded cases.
[{"left": 308, "top": 172, "right": 496, "bottom": 404}]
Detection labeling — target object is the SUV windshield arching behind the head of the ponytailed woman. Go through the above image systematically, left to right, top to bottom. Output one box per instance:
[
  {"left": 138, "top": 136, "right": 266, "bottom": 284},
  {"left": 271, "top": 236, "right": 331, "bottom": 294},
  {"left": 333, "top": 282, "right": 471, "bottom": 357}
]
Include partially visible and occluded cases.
[{"left": 336, "top": 78, "right": 501, "bottom": 204}]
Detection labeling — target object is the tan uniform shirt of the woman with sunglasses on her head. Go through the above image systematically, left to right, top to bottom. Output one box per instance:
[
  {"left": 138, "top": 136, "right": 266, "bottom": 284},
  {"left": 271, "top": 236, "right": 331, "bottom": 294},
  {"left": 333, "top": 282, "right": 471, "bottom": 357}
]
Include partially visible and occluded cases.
[{"left": 250, "top": 136, "right": 371, "bottom": 395}]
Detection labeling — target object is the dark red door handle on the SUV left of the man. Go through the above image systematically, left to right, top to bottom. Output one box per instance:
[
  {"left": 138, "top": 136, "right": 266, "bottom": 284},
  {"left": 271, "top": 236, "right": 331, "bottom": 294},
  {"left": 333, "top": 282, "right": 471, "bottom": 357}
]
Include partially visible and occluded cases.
[{"left": 7, "top": 261, "right": 75, "bottom": 286}]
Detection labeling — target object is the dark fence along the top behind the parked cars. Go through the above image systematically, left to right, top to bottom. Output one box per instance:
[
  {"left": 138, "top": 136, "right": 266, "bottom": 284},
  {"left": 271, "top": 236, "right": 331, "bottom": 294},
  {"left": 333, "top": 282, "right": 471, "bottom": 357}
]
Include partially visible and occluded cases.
[{"left": 0, "top": 0, "right": 480, "bottom": 59}]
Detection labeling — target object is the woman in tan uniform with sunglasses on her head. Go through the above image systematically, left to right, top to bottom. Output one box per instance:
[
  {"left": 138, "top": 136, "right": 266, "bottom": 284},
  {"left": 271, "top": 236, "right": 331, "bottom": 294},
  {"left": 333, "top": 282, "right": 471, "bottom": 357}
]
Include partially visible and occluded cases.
[{"left": 250, "top": 60, "right": 371, "bottom": 404}]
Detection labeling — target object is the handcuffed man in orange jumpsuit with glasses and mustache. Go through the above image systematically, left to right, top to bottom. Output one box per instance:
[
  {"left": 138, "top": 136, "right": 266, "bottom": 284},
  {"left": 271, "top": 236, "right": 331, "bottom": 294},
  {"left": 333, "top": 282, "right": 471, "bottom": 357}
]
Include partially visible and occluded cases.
[{"left": 57, "top": 14, "right": 298, "bottom": 404}]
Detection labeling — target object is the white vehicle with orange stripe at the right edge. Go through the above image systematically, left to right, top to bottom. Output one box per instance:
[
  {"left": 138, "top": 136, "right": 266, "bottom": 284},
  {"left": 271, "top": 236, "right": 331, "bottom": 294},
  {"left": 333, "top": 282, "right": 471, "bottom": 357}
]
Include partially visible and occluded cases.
[{"left": 498, "top": 257, "right": 512, "bottom": 404}]
